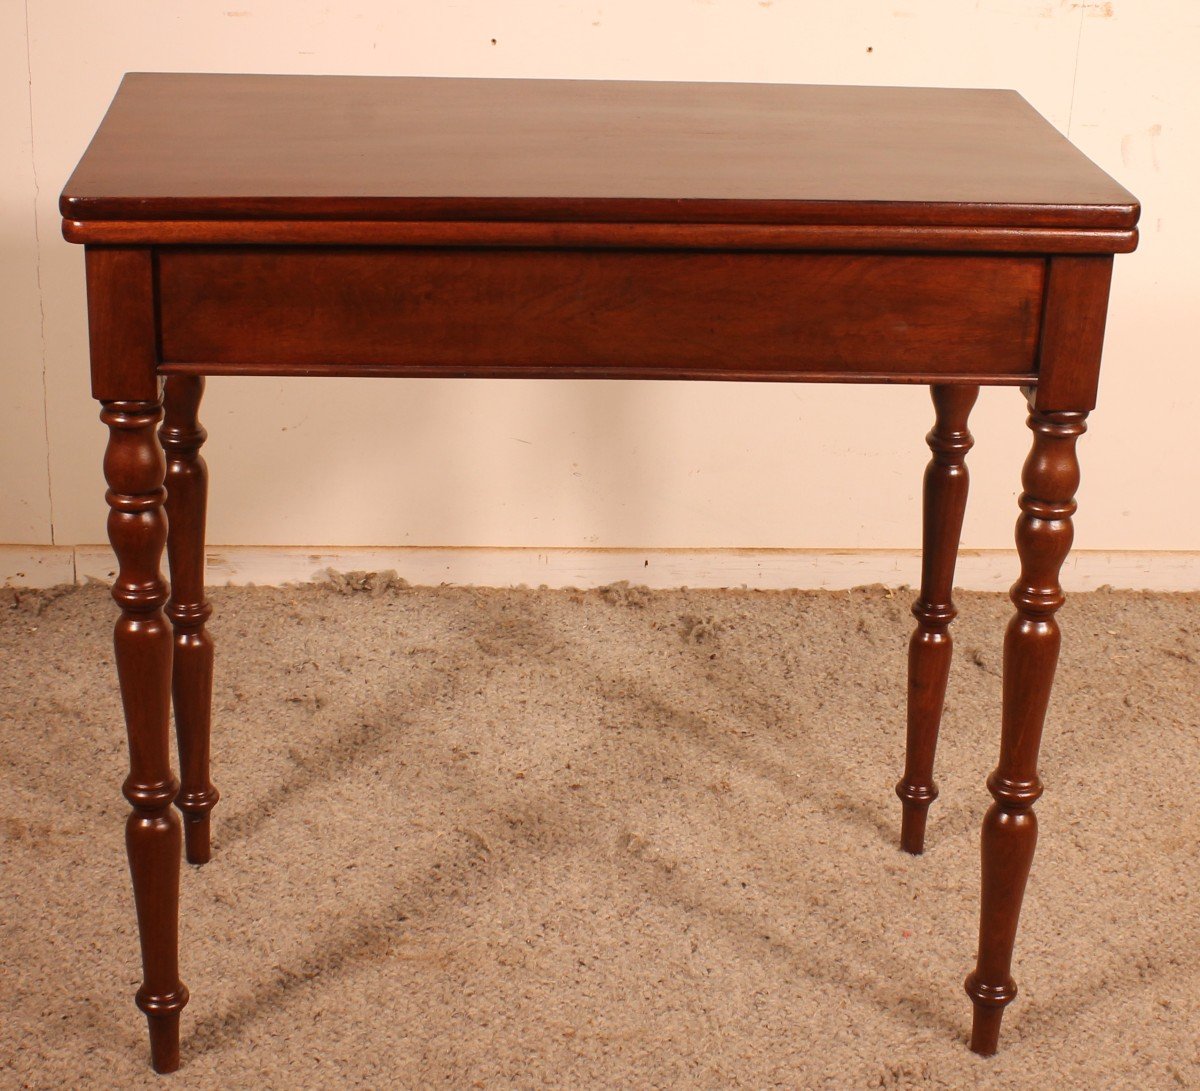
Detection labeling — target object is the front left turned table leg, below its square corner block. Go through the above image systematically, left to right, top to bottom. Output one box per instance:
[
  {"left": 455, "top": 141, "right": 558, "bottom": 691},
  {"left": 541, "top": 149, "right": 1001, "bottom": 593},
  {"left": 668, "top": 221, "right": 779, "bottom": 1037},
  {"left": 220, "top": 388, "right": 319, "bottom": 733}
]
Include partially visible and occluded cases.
[{"left": 100, "top": 401, "right": 187, "bottom": 1072}]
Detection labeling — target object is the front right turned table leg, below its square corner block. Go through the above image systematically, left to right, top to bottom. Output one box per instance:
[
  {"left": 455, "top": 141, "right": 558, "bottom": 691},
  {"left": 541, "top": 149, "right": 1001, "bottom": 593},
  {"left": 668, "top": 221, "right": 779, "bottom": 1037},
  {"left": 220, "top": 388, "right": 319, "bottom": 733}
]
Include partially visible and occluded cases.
[{"left": 966, "top": 409, "right": 1087, "bottom": 1056}]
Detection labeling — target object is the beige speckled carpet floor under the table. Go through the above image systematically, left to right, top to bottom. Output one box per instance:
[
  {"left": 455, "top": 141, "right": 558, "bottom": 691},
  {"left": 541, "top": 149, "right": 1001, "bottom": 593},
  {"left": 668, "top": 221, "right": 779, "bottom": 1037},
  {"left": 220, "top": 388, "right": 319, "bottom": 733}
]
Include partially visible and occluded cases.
[{"left": 0, "top": 583, "right": 1200, "bottom": 1089}]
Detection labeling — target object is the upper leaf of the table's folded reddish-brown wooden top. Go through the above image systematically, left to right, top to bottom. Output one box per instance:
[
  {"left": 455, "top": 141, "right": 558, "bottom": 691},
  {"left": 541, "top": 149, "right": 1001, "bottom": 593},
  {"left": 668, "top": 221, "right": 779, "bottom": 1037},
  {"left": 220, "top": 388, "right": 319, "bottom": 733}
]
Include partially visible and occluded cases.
[{"left": 61, "top": 72, "right": 1139, "bottom": 229}]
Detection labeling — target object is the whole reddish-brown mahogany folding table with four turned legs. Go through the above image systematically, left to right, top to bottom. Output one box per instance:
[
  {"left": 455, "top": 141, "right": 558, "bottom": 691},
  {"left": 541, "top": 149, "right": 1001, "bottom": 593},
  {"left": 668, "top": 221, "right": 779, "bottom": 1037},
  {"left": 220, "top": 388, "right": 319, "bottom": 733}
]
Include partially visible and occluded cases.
[{"left": 61, "top": 73, "right": 1139, "bottom": 1072}]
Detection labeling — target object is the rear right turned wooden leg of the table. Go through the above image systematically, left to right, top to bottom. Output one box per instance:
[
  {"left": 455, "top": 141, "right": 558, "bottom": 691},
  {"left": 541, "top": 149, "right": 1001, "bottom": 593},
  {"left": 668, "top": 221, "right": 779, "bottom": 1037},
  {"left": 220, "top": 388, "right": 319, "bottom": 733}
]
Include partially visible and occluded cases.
[{"left": 896, "top": 386, "right": 979, "bottom": 853}]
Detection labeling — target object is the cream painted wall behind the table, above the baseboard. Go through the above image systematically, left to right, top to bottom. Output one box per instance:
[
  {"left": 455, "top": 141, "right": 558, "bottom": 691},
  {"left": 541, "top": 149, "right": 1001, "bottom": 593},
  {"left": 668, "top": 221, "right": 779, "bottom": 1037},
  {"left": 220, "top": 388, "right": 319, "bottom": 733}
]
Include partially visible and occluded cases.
[{"left": 0, "top": 0, "right": 1200, "bottom": 550}]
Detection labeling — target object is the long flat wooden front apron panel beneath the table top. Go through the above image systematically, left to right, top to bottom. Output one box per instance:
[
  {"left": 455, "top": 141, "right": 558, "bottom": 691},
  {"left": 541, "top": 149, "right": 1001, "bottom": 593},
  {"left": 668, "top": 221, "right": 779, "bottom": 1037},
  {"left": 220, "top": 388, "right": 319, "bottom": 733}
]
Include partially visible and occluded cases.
[{"left": 156, "top": 246, "right": 1046, "bottom": 378}]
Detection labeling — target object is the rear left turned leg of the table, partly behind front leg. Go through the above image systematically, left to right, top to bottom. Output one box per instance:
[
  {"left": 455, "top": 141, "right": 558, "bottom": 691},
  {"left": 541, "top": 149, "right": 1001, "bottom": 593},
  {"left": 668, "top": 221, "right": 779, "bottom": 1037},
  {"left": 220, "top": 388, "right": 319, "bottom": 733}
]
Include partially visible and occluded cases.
[{"left": 158, "top": 374, "right": 220, "bottom": 864}]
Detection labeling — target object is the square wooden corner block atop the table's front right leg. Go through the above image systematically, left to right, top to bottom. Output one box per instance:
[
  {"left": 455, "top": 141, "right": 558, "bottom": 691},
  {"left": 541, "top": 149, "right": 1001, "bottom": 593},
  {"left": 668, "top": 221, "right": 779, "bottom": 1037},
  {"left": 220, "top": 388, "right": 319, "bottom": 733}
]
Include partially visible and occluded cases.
[{"left": 1036, "top": 256, "right": 1112, "bottom": 410}]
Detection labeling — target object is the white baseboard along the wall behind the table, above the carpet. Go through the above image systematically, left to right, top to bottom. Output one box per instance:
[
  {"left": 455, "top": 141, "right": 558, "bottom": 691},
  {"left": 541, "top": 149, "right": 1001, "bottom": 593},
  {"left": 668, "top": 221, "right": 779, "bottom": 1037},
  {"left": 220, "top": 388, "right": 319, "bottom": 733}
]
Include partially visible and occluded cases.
[{"left": 0, "top": 545, "right": 1200, "bottom": 591}]
